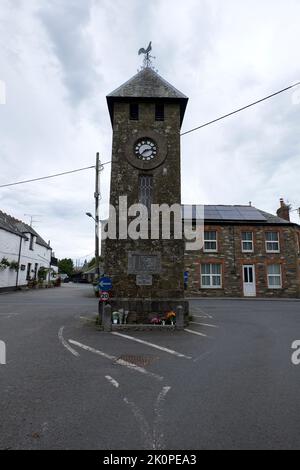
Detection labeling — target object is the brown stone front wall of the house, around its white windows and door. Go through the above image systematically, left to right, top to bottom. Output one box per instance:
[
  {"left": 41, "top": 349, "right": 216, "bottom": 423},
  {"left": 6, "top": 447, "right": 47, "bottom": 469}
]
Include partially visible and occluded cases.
[{"left": 185, "top": 225, "right": 300, "bottom": 297}]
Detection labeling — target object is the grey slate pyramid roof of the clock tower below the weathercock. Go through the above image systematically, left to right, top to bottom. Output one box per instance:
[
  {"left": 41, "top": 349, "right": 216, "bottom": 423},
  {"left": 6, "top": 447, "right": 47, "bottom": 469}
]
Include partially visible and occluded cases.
[{"left": 106, "top": 67, "right": 188, "bottom": 125}]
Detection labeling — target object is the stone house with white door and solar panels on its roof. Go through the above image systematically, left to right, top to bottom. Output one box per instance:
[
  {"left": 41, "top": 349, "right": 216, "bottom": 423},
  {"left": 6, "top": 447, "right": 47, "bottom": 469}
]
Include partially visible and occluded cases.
[{"left": 183, "top": 199, "right": 300, "bottom": 297}]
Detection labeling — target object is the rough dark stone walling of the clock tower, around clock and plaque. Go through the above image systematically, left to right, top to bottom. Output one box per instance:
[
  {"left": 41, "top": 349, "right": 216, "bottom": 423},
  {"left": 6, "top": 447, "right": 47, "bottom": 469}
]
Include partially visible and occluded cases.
[{"left": 105, "top": 102, "right": 184, "bottom": 299}]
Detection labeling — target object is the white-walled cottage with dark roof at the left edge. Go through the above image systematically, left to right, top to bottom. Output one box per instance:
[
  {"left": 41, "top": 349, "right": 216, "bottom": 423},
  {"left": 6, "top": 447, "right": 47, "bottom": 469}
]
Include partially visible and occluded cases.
[{"left": 0, "top": 211, "right": 52, "bottom": 291}]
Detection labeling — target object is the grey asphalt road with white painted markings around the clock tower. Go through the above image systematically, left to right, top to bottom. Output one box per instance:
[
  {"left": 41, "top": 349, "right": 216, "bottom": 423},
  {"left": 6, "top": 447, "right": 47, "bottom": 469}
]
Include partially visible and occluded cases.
[{"left": 0, "top": 284, "right": 300, "bottom": 450}]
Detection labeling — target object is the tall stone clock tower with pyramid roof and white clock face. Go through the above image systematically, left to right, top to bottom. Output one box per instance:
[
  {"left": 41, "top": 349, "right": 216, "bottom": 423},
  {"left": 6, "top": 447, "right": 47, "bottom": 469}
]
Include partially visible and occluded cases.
[{"left": 104, "top": 57, "right": 188, "bottom": 322}]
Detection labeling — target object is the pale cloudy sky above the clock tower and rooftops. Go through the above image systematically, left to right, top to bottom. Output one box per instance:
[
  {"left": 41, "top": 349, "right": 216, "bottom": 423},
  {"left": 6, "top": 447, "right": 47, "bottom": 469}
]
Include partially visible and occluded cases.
[{"left": 0, "top": 0, "right": 300, "bottom": 260}]
